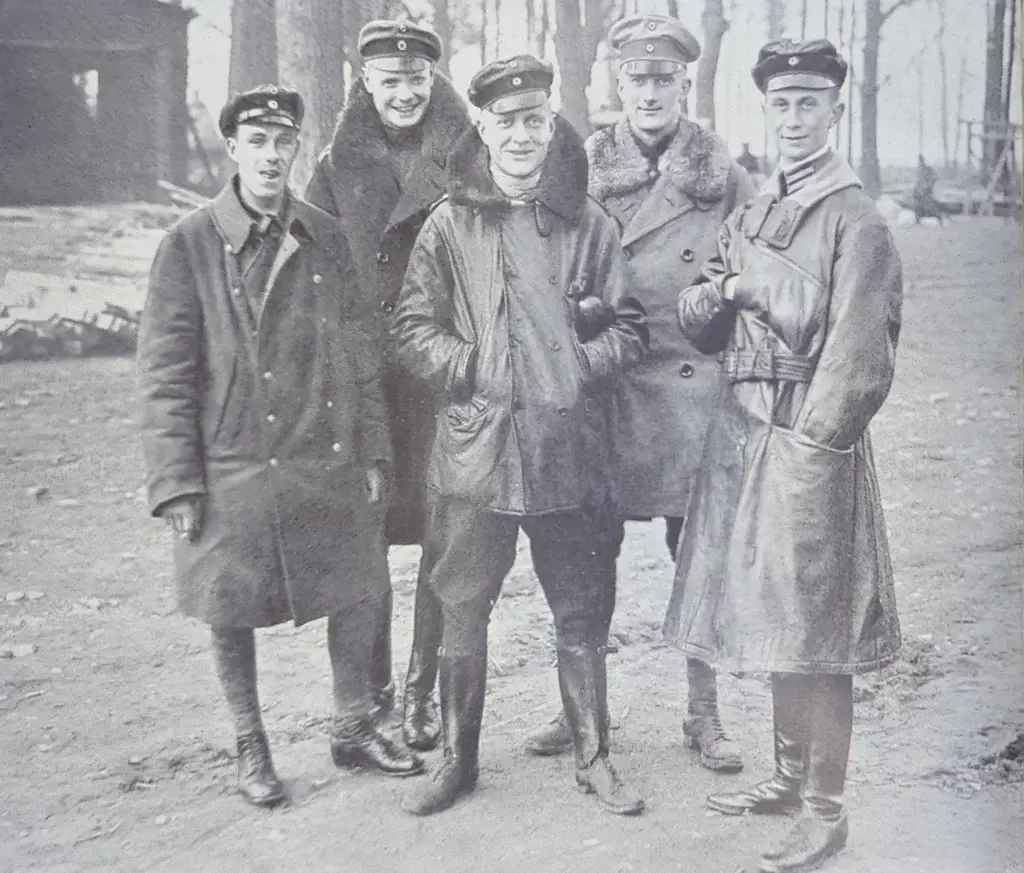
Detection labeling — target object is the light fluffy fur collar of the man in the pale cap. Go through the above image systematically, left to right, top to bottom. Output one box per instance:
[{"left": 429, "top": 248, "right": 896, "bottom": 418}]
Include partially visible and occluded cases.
[{"left": 587, "top": 117, "right": 732, "bottom": 203}]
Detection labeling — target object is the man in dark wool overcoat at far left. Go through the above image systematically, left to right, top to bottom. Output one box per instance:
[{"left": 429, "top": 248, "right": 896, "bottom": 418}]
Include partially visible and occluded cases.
[{"left": 138, "top": 86, "right": 423, "bottom": 806}]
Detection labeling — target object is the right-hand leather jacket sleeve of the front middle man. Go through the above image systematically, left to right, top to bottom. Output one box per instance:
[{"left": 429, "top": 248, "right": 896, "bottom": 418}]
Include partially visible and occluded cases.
[{"left": 581, "top": 218, "right": 650, "bottom": 379}]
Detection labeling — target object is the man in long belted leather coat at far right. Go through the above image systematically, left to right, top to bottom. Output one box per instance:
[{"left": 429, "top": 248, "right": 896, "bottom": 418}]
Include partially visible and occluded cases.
[{"left": 666, "top": 40, "right": 902, "bottom": 873}]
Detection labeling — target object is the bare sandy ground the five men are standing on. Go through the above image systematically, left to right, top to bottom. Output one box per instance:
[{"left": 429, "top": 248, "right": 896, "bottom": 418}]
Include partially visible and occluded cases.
[{"left": 0, "top": 219, "right": 1024, "bottom": 873}]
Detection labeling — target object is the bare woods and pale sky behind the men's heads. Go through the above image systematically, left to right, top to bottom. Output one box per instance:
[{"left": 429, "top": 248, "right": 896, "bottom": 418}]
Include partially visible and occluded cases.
[{"left": 218, "top": 0, "right": 1021, "bottom": 195}]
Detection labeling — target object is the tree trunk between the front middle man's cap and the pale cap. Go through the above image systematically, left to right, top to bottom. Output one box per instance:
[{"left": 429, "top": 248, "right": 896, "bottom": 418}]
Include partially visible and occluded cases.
[{"left": 555, "top": 0, "right": 604, "bottom": 136}]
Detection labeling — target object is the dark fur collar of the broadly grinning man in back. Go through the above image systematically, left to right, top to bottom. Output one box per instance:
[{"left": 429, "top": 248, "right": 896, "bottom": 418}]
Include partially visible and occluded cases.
[{"left": 330, "top": 73, "right": 470, "bottom": 177}]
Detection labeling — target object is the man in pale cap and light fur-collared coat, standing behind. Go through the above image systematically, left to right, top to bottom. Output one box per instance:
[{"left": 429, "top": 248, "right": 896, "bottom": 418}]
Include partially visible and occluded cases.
[{"left": 527, "top": 15, "right": 754, "bottom": 772}]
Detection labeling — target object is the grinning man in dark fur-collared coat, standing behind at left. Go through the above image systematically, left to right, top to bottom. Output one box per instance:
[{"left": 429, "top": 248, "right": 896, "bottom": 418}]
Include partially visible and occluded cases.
[{"left": 306, "top": 21, "right": 470, "bottom": 750}]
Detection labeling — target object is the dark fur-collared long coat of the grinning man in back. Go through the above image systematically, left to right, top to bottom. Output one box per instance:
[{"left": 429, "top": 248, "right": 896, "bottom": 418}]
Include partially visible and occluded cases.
[{"left": 306, "top": 73, "right": 470, "bottom": 543}]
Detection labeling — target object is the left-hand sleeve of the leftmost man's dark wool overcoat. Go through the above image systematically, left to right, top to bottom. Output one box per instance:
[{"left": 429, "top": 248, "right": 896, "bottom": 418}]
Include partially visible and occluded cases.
[{"left": 137, "top": 230, "right": 206, "bottom": 516}]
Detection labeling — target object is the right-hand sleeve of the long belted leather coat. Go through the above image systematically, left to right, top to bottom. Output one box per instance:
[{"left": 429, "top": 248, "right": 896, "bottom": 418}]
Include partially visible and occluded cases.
[{"left": 794, "top": 214, "right": 903, "bottom": 448}]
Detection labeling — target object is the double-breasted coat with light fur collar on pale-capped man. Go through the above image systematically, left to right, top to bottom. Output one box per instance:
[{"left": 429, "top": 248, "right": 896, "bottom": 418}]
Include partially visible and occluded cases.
[{"left": 587, "top": 119, "right": 754, "bottom": 518}]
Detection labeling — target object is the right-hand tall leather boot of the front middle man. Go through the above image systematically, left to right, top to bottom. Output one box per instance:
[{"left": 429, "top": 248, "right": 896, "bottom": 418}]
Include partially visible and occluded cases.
[{"left": 558, "top": 646, "right": 644, "bottom": 816}]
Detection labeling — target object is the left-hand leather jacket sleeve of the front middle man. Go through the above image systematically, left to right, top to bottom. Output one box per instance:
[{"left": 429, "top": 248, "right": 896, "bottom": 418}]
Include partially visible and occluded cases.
[{"left": 390, "top": 213, "right": 476, "bottom": 394}]
